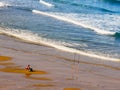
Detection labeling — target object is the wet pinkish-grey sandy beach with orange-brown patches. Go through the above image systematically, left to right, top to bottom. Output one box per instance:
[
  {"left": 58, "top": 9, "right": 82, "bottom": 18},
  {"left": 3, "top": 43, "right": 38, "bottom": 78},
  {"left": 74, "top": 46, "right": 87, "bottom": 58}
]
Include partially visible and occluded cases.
[{"left": 0, "top": 35, "right": 120, "bottom": 90}]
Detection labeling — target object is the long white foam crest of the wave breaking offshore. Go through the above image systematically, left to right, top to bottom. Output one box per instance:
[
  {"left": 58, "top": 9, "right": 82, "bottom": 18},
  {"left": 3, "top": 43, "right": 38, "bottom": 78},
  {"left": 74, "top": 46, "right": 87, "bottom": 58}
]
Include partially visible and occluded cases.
[{"left": 32, "top": 10, "right": 115, "bottom": 35}]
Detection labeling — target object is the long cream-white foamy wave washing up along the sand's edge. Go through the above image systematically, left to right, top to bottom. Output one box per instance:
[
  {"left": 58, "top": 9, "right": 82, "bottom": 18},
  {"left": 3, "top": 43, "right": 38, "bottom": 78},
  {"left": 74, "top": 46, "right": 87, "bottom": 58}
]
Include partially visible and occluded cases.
[{"left": 0, "top": 27, "right": 120, "bottom": 62}]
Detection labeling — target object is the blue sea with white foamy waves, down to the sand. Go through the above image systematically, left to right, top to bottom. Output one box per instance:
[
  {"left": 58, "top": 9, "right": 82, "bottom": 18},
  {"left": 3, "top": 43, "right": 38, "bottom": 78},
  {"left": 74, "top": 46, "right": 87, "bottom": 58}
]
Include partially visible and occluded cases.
[{"left": 0, "top": 0, "right": 120, "bottom": 60}]
